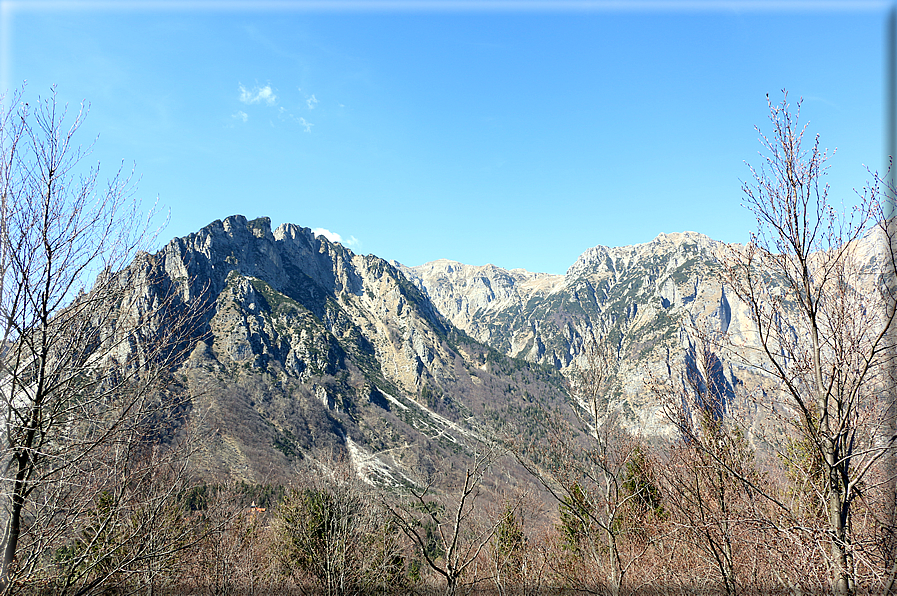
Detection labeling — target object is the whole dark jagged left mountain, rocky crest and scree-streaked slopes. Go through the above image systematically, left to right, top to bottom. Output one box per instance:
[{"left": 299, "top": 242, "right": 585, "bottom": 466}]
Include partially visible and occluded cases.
[{"left": 124, "top": 216, "right": 564, "bottom": 483}]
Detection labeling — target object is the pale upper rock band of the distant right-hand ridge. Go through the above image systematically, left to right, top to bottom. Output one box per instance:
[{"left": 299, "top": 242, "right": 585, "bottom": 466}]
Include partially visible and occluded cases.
[{"left": 400, "top": 232, "right": 737, "bottom": 358}]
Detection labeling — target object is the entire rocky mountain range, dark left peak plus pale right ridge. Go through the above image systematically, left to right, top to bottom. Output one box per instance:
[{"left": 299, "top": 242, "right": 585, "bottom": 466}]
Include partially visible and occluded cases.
[{"left": 110, "top": 216, "right": 883, "bottom": 483}]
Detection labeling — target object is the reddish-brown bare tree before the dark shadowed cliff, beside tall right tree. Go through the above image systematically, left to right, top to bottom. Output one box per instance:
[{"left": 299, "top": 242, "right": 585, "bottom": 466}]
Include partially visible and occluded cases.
[{"left": 651, "top": 326, "right": 763, "bottom": 595}]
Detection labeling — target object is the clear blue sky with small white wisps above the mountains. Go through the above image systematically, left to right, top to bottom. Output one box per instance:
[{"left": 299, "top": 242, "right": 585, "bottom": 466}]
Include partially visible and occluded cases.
[{"left": 0, "top": 0, "right": 890, "bottom": 273}]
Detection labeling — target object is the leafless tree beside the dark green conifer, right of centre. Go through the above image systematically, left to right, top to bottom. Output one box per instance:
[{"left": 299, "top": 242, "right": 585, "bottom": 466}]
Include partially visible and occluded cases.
[{"left": 518, "top": 333, "right": 660, "bottom": 596}]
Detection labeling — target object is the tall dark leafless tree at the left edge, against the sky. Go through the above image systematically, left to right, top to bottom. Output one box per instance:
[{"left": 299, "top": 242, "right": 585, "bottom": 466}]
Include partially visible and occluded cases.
[{"left": 0, "top": 89, "right": 201, "bottom": 591}]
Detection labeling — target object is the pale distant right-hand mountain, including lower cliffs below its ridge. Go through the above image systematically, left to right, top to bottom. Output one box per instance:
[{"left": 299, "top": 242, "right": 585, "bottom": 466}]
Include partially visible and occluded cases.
[{"left": 401, "top": 232, "right": 768, "bottom": 436}]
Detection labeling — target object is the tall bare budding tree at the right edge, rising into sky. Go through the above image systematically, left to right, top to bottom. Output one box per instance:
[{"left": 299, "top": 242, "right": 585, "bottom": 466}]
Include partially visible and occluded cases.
[{"left": 725, "top": 94, "right": 895, "bottom": 594}]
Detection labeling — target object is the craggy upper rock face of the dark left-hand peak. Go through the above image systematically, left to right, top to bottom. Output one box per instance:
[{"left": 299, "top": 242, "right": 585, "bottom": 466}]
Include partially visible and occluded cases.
[{"left": 153, "top": 216, "right": 456, "bottom": 392}]
